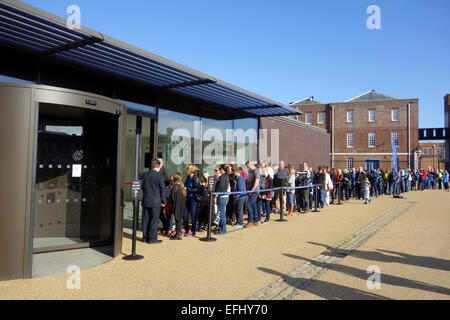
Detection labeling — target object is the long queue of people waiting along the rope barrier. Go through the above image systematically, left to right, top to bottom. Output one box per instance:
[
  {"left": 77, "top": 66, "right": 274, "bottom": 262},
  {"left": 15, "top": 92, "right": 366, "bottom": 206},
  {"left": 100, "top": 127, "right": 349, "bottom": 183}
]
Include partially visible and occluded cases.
[{"left": 141, "top": 159, "right": 449, "bottom": 243}]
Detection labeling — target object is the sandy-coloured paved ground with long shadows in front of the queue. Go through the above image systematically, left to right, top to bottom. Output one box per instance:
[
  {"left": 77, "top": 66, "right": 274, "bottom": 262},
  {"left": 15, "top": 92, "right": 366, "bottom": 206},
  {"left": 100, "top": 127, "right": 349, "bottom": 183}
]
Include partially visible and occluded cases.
[{"left": 0, "top": 191, "right": 450, "bottom": 299}]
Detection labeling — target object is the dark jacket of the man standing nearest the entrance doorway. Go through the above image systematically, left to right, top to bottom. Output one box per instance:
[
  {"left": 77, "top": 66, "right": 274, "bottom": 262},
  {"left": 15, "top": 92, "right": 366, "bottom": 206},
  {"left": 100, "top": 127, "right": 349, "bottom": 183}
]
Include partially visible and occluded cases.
[{"left": 141, "top": 170, "right": 167, "bottom": 208}]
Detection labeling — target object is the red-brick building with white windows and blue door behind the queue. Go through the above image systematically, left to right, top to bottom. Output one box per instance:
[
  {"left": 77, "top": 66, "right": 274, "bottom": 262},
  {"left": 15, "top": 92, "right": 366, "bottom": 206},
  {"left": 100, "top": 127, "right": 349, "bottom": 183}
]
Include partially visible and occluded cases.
[{"left": 290, "top": 90, "right": 419, "bottom": 169}]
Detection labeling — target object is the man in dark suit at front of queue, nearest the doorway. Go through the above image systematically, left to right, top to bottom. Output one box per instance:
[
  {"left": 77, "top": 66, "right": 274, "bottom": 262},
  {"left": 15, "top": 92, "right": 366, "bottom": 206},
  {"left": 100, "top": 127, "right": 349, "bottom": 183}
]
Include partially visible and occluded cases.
[{"left": 141, "top": 159, "right": 167, "bottom": 243}]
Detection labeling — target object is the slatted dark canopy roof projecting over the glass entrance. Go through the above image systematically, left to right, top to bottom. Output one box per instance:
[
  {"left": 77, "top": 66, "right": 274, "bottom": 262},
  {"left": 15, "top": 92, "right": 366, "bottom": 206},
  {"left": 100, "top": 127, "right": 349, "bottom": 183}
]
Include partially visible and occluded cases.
[{"left": 0, "top": 0, "right": 301, "bottom": 117}]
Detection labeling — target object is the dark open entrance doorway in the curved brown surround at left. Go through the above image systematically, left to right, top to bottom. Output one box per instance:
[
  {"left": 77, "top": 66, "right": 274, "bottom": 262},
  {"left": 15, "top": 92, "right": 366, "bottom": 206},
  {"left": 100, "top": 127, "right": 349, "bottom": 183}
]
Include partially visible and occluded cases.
[{"left": 33, "top": 103, "right": 118, "bottom": 254}]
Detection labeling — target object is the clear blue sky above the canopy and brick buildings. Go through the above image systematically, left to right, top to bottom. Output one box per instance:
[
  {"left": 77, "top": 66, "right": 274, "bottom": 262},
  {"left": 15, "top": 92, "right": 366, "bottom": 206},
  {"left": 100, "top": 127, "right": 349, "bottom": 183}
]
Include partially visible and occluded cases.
[{"left": 24, "top": 0, "right": 450, "bottom": 128}]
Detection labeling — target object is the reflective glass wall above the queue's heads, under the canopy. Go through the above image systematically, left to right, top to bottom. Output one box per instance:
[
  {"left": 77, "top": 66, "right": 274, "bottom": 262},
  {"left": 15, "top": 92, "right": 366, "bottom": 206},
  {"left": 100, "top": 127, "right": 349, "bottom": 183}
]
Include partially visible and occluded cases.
[{"left": 158, "top": 109, "right": 258, "bottom": 178}]
